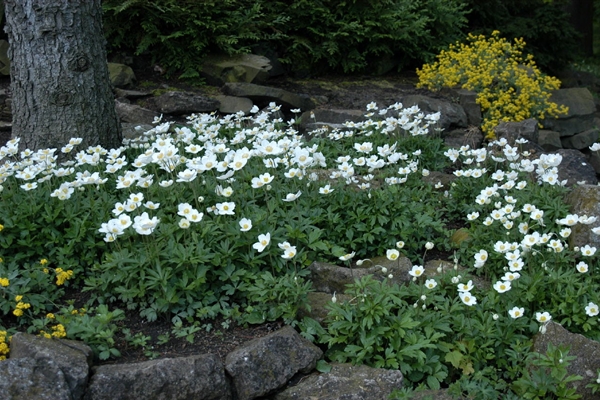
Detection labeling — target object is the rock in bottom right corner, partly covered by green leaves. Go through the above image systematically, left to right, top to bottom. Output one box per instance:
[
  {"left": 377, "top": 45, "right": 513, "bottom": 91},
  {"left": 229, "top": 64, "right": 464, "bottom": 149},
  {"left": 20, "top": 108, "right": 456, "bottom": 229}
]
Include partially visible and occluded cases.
[{"left": 533, "top": 321, "right": 600, "bottom": 400}]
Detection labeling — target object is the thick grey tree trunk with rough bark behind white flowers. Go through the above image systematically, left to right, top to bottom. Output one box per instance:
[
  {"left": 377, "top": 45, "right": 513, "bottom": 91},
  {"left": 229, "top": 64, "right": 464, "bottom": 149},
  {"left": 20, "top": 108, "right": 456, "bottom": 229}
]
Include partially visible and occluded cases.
[{"left": 5, "top": 0, "right": 121, "bottom": 150}]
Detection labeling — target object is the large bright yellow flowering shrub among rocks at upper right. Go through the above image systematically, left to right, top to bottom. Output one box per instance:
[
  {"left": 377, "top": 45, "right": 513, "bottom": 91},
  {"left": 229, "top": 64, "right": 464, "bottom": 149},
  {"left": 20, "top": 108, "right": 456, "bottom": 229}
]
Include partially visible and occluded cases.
[{"left": 417, "top": 31, "right": 568, "bottom": 139}]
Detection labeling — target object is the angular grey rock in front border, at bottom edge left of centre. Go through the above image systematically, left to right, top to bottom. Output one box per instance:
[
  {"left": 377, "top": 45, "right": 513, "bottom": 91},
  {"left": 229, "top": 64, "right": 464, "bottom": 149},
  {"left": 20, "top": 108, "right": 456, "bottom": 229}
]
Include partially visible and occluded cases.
[{"left": 225, "top": 326, "right": 323, "bottom": 400}]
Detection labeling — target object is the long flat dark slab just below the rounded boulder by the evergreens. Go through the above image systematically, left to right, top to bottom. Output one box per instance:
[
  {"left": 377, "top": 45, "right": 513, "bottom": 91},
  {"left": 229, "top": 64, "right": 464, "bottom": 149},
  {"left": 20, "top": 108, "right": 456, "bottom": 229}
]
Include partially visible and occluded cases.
[{"left": 223, "top": 83, "right": 314, "bottom": 111}]
